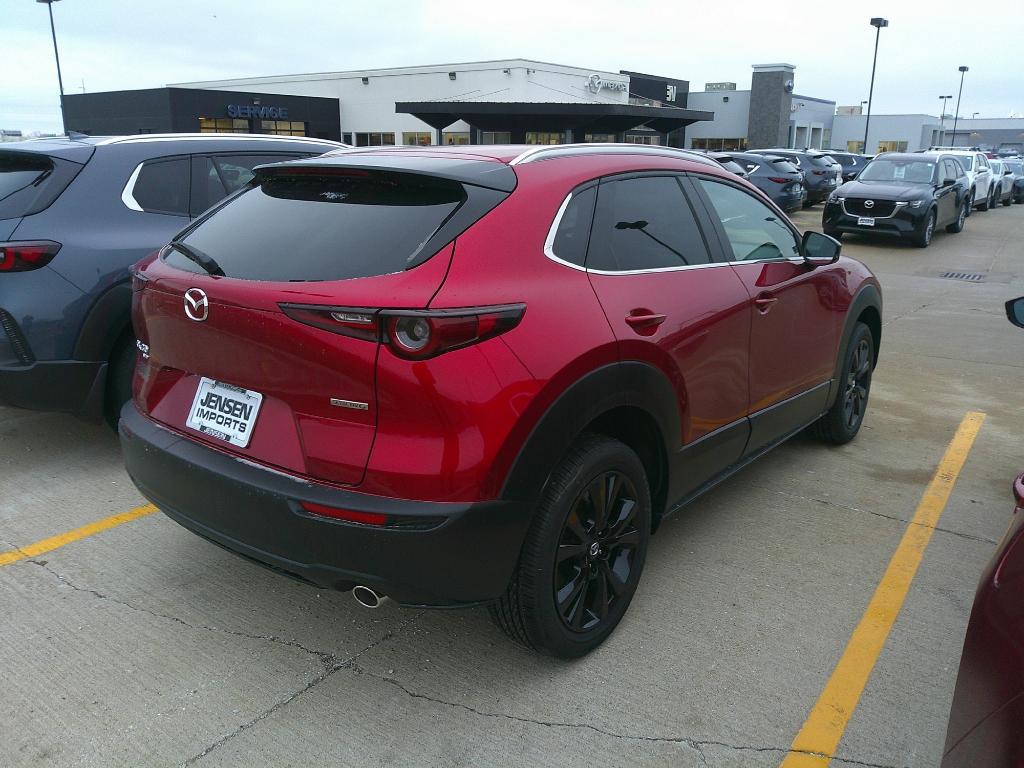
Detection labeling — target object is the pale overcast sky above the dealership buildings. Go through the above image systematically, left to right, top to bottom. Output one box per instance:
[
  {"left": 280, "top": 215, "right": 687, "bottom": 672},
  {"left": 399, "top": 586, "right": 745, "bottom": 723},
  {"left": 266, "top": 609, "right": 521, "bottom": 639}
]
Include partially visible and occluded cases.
[{"left": 0, "top": 0, "right": 1024, "bottom": 131}]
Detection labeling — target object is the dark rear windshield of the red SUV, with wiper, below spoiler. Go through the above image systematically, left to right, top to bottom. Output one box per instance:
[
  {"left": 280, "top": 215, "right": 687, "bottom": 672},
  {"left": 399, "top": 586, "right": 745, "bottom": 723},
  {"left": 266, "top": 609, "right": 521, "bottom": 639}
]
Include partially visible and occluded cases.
[{"left": 172, "top": 168, "right": 466, "bottom": 281}]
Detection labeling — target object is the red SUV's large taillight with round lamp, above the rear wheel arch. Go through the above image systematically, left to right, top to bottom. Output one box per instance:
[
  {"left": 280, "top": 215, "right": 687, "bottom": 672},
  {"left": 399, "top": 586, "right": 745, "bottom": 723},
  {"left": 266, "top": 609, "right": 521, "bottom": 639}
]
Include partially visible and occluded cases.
[{"left": 281, "top": 304, "right": 526, "bottom": 360}]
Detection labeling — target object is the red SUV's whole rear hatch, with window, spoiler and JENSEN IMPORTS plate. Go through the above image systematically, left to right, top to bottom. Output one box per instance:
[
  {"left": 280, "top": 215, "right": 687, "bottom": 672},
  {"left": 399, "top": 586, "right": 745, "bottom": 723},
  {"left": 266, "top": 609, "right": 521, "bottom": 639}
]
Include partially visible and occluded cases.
[{"left": 133, "top": 155, "right": 514, "bottom": 484}]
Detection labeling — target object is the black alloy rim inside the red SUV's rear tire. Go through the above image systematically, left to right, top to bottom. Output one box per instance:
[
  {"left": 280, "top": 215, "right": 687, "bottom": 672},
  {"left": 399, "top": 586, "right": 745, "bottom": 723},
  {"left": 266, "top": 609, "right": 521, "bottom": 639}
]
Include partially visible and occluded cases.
[{"left": 554, "top": 471, "right": 640, "bottom": 632}]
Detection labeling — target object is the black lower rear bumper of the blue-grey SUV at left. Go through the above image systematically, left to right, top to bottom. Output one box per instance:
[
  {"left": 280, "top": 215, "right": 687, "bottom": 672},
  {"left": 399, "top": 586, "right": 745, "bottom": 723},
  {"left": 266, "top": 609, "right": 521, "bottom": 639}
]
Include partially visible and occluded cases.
[{"left": 0, "top": 360, "right": 106, "bottom": 419}]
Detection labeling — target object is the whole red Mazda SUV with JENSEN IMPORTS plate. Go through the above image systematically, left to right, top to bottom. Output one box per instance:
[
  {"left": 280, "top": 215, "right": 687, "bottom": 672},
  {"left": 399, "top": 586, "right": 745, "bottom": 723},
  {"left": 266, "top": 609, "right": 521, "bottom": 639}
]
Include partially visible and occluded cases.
[{"left": 120, "top": 144, "right": 882, "bottom": 657}]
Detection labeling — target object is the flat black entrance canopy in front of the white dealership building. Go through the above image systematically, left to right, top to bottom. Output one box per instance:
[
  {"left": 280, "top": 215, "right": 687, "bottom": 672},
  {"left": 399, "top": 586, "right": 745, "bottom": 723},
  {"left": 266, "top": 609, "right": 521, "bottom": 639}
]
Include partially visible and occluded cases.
[{"left": 394, "top": 101, "right": 715, "bottom": 137}]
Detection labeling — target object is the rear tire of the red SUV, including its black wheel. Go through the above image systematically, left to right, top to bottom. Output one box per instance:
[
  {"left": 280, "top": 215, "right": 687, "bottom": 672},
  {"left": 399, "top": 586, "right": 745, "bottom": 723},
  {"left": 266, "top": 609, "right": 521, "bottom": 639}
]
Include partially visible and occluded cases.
[{"left": 489, "top": 434, "right": 651, "bottom": 658}]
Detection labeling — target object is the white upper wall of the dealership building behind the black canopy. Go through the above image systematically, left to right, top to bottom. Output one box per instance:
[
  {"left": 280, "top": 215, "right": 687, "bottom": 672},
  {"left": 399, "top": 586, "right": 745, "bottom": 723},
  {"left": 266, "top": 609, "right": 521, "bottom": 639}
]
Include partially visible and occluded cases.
[{"left": 172, "top": 58, "right": 629, "bottom": 144}]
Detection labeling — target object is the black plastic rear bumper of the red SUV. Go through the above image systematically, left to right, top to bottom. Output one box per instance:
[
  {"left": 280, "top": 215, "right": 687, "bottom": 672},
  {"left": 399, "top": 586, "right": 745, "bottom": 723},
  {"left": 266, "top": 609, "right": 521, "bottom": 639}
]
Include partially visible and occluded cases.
[{"left": 120, "top": 402, "right": 529, "bottom": 607}]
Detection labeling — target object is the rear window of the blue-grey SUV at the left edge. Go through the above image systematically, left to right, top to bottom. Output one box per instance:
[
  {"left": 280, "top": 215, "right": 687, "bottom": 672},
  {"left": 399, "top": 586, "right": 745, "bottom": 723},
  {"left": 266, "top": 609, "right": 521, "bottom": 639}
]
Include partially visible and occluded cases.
[{"left": 0, "top": 152, "right": 82, "bottom": 220}]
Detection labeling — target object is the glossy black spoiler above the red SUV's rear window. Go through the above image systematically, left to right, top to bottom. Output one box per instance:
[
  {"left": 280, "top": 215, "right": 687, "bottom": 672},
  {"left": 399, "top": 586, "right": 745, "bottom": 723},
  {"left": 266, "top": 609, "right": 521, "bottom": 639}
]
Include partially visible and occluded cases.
[{"left": 253, "top": 150, "right": 518, "bottom": 193}]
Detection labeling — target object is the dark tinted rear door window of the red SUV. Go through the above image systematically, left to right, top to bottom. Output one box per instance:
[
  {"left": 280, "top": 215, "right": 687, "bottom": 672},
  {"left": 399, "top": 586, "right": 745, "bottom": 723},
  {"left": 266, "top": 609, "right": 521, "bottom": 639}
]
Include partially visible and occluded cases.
[{"left": 587, "top": 176, "right": 711, "bottom": 271}]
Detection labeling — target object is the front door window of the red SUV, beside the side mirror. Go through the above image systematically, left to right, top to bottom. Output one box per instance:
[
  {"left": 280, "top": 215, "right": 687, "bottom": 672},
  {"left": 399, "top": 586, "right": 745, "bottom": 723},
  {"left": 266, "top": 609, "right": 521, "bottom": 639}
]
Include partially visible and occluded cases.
[{"left": 699, "top": 179, "right": 800, "bottom": 261}]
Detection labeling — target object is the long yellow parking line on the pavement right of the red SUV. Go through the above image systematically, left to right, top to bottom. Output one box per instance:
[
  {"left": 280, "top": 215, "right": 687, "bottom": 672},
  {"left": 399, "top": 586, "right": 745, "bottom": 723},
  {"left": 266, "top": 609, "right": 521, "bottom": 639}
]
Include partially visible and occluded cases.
[{"left": 781, "top": 411, "right": 985, "bottom": 768}]
